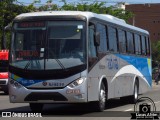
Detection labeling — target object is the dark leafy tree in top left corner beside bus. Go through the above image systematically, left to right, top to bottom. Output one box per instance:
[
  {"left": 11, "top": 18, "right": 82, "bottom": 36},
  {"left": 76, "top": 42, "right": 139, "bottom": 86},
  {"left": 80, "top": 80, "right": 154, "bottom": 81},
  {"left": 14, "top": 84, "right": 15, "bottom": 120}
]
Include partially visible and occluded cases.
[{"left": 0, "top": 0, "right": 36, "bottom": 49}]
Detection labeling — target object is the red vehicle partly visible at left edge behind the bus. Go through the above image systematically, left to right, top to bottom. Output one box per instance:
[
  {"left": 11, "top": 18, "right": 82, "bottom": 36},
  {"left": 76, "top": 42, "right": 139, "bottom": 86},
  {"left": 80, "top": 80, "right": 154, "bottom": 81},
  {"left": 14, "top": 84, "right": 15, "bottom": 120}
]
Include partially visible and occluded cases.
[{"left": 0, "top": 50, "right": 9, "bottom": 94}]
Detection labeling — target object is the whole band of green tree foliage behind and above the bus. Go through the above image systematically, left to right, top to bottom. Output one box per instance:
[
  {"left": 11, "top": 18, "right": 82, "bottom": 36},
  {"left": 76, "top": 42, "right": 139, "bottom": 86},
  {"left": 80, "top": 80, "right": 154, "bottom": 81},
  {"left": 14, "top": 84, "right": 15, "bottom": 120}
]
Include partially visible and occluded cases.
[{"left": 0, "top": 0, "right": 133, "bottom": 47}]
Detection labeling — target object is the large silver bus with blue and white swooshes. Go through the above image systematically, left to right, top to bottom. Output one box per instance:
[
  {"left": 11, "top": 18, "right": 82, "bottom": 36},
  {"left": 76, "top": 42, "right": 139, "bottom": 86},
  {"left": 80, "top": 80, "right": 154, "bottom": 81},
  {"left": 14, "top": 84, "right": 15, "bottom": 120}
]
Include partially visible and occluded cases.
[{"left": 9, "top": 11, "right": 152, "bottom": 111}]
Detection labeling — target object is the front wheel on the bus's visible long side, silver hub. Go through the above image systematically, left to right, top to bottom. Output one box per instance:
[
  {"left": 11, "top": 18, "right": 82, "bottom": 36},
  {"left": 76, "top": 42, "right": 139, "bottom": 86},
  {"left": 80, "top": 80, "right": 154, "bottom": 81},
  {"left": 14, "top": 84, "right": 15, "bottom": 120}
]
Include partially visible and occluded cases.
[{"left": 94, "top": 82, "right": 106, "bottom": 112}]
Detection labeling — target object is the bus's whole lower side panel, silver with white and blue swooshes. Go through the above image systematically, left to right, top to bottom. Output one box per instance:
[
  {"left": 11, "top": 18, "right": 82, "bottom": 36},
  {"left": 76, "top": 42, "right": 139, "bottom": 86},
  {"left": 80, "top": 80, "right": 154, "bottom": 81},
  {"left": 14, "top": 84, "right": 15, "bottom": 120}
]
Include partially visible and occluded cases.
[{"left": 88, "top": 54, "right": 151, "bottom": 101}]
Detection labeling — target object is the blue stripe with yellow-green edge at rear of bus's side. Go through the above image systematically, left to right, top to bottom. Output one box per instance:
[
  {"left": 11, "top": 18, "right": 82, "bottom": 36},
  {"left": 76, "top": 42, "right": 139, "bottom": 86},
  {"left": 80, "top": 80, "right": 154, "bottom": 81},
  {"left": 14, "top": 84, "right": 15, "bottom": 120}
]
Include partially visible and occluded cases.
[{"left": 116, "top": 54, "right": 152, "bottom": 86}]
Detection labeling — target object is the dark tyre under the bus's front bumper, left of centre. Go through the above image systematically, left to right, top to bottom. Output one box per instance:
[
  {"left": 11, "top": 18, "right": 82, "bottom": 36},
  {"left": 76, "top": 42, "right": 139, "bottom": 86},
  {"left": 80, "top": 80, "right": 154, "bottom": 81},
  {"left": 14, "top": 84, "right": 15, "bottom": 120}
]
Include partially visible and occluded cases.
[{"left": 29, "top": 103, "right": 43, "bottom": 112}]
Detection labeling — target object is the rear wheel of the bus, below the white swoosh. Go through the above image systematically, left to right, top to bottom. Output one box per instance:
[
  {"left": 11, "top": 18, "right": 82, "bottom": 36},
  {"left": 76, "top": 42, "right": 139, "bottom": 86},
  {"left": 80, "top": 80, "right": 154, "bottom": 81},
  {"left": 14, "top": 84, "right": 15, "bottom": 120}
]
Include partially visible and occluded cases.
[{"left": 130, "top": 80, "right": 139, "bottom": 103}]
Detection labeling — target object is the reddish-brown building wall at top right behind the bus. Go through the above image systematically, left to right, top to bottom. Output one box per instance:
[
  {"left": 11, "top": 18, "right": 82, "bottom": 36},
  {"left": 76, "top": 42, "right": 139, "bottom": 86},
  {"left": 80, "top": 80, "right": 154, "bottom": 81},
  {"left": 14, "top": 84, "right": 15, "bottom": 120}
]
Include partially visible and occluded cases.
[{"left": 126, "top": 4, "right": 160, "bottom": 41}]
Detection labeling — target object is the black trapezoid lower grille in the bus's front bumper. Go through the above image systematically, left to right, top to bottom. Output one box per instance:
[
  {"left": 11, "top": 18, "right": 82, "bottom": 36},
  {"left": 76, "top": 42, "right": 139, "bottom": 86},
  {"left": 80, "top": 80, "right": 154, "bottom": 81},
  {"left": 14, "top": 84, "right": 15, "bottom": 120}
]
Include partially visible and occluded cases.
[{"left": 24, "top": 92, "right": 67, "bottom": 101}]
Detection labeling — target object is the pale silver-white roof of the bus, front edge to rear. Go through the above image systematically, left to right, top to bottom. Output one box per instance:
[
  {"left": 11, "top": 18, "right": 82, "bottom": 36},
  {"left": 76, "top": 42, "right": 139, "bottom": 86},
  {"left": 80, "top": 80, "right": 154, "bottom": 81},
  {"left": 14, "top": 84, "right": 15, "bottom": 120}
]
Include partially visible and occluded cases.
[{"left": 15, "top": 11, "right": 149, "bottom": 34}]
